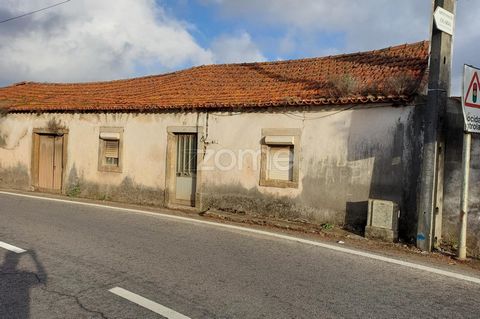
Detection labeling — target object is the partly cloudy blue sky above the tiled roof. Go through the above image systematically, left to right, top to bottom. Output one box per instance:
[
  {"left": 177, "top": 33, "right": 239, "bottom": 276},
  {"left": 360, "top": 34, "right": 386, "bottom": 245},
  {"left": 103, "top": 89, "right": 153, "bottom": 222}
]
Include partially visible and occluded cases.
[{"left": 0, "top": 0, "right": 480, "bottom": 95}]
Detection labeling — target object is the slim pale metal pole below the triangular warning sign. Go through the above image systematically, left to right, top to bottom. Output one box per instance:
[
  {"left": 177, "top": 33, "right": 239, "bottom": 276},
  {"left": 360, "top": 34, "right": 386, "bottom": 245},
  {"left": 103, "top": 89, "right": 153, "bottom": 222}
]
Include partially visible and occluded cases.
[{"left": 458, "top": 132, "right": 472, "bottom": 260}]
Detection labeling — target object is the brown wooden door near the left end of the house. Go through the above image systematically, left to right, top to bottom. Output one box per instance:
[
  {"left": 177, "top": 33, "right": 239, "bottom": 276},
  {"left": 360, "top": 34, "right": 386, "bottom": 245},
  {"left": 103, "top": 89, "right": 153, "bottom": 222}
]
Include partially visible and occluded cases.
[{"left": 38, "top": 135, "right": 63, "bottom": 190}]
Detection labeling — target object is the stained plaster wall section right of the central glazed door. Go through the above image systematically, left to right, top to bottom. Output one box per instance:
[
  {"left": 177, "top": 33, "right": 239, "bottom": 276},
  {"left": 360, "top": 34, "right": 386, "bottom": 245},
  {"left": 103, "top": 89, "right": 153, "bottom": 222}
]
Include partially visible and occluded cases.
[{"left": 202, "top": 107, "right": 420, "bottom": 238}]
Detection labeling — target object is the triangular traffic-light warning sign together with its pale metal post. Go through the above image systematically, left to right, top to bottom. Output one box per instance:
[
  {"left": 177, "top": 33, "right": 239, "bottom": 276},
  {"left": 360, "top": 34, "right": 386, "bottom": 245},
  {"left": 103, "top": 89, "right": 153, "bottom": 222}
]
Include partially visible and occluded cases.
[{"left": 457, "top": 65, "right": 480, "bottom": 260}]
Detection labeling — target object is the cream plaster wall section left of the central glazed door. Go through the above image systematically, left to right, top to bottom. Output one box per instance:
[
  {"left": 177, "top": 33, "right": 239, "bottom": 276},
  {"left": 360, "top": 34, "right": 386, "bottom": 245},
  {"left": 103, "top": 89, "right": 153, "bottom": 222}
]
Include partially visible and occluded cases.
[{"left": 0, "top": 114, "right": 182, "bottom": 205}]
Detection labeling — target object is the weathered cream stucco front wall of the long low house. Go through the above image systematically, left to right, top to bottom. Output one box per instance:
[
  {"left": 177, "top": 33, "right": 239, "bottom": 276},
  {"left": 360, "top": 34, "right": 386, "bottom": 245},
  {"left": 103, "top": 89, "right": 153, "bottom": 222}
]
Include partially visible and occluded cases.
[{"left": 0, "top": 106, "right": 420, "bottom": 237}]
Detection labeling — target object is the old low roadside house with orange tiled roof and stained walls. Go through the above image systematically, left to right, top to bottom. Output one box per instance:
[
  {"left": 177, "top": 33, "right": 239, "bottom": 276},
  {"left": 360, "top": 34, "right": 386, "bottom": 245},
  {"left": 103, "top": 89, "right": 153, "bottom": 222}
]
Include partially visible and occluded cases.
[{"left": 0, "top": 42, "right": 478, "bottom": 254}]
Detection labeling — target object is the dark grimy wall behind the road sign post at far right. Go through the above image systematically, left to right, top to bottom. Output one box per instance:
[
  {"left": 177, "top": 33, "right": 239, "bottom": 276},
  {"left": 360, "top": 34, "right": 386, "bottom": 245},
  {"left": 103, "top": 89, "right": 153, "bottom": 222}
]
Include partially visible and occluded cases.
[{"left": 442, "top": 100, "right": 480, "bottom": 257}]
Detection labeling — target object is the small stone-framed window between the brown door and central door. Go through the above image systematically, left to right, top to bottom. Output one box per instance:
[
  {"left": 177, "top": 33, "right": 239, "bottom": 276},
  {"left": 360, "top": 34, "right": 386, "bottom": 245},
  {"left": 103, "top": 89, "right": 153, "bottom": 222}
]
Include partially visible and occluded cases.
[{"left": 98, "top": 128, "right": 123, "bottom": 172}]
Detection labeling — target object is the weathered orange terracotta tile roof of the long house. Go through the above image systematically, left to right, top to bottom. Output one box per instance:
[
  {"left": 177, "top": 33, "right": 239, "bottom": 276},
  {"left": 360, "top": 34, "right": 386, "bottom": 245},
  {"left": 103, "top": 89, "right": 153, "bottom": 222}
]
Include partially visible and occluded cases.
[{"left": 0, "top": 42, "right": 429, "bottom": 112}]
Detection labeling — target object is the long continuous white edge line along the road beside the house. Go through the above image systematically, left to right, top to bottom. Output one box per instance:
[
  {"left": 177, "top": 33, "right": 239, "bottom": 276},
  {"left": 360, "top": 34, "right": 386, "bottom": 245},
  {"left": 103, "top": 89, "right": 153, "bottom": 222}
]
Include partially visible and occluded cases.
[{"left": 0, "top": 191, "right": 480, "bottom": 284}]
